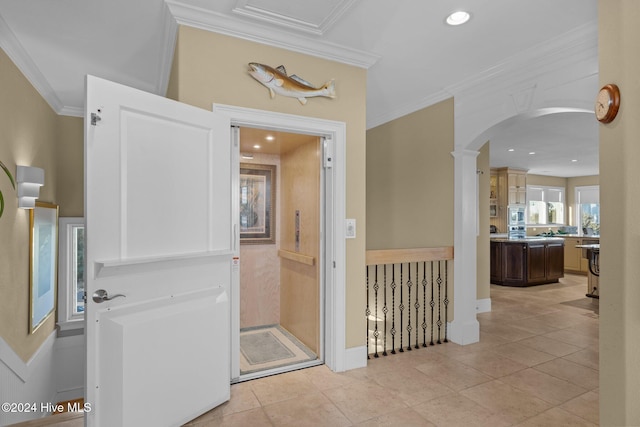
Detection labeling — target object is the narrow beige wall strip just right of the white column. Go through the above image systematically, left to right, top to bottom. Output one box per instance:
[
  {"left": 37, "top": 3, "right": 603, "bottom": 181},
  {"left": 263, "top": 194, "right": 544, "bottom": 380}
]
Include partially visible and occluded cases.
[{"left": 476, "top": 142, "right": 491, "bottom": 300}]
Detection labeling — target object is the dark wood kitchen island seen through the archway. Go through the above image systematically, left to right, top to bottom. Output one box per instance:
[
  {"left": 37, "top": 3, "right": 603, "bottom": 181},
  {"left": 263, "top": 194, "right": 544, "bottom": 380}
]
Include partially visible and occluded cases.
[{"left": 490, "top": 237, "right": 564, "bottom": 286}]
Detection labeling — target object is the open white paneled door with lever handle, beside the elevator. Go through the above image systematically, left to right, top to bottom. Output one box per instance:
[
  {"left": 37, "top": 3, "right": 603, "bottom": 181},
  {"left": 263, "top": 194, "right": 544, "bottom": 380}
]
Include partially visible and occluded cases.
[{"left": 85, "top": 76, "right": 235, "bottom": 427}]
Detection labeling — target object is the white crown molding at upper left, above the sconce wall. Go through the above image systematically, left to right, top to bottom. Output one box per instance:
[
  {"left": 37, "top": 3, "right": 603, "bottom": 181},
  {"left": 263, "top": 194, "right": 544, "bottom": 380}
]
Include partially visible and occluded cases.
[{"left": 0, "top": 16, "right": 64, "bottom": 113}]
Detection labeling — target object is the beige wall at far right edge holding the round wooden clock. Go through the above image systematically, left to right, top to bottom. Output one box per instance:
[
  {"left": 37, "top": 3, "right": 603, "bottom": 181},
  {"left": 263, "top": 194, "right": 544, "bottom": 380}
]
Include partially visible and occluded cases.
[{"left": 594, "top": 0, "right": 640, "bottom": 426}]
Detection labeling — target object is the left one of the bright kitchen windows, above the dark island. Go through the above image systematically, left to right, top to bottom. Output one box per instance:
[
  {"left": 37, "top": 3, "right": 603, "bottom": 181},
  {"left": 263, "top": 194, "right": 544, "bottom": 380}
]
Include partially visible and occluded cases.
[{"left": 527, "top": 185, "right": 565, "bottom": 225}]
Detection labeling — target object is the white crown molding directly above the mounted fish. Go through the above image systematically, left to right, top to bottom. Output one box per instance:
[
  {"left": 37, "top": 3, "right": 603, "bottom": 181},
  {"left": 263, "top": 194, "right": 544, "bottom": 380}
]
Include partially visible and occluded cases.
[{"left": 166, "top": 0, "right": 380, "bottom": 69}]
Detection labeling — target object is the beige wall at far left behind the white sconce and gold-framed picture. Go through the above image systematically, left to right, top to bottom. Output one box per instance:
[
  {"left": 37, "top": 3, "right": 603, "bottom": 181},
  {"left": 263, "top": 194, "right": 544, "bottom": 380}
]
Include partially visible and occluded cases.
[{"left": 0, "top": 46, "right": 58, "bottom": 361}]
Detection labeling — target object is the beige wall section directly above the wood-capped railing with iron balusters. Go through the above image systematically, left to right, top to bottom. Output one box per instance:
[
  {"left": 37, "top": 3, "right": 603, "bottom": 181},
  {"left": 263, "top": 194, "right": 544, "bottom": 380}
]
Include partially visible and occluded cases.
[{"left": 367, "top": 98, "right": 456, "bottom": 249}]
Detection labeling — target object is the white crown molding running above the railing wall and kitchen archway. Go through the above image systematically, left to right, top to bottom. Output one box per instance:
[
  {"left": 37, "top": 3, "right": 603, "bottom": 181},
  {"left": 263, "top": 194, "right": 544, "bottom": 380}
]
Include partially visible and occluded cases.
[{"left": 367, "top": 21, "right": 598, "bottom": 129}]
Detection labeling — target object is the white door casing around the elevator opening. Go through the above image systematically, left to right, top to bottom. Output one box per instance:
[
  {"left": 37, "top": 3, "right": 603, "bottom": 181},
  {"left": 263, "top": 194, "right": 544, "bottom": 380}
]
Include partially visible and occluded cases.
[{"left": 213, "top": 104, "right": 344, "bottom": 383}]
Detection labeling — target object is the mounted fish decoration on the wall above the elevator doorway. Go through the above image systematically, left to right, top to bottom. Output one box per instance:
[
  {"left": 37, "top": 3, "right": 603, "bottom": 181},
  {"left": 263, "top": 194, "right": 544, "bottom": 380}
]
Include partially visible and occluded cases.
[{"left": 249, "top": 62, "right": 336, "bottom": 105}]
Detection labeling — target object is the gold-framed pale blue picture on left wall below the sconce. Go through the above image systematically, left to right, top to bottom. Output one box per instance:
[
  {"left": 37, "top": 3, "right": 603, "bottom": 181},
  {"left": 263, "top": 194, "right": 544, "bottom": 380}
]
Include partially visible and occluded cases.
[{"left": 29, "top": 202, "right": 58, "bottom": 334}]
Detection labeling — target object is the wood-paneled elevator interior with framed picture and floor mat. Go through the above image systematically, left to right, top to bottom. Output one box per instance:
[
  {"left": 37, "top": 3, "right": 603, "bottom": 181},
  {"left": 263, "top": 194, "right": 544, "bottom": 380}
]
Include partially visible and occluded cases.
[{"left": 238, "top": 127, "right": 324, "bottom": 381}]
